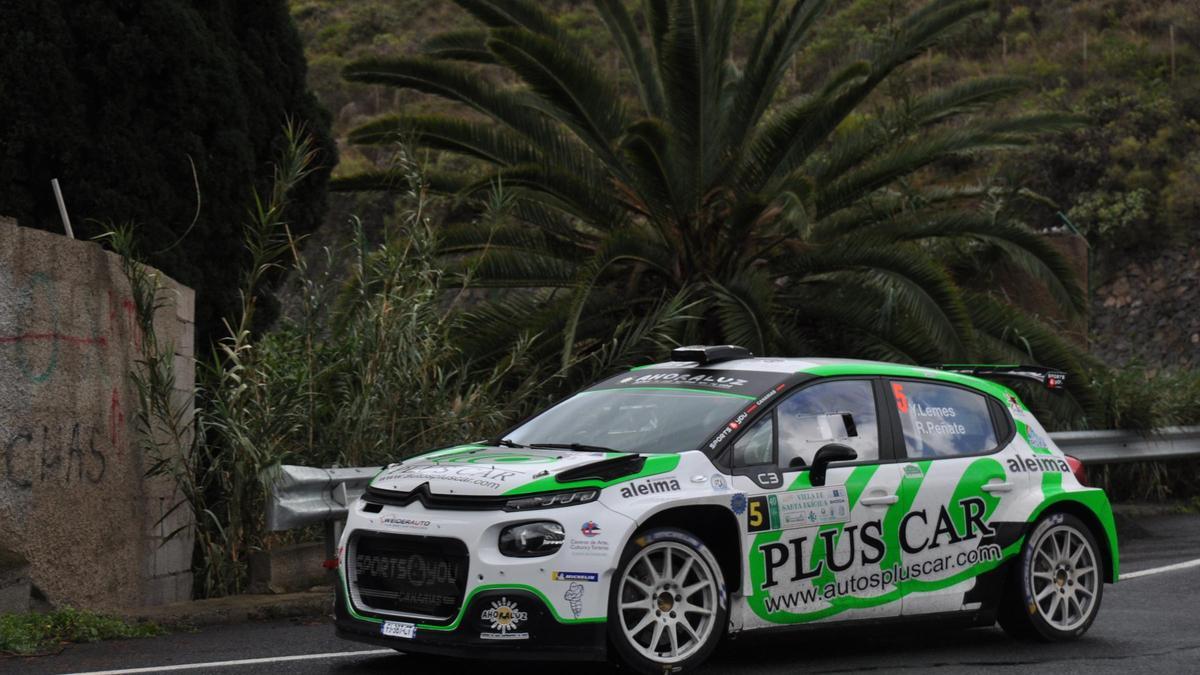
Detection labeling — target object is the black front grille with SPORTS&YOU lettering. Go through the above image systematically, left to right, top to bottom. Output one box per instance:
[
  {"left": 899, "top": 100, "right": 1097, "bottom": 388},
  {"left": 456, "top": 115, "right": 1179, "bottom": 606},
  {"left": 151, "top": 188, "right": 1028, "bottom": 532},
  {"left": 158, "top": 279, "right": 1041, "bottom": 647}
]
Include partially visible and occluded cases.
[{"left": 347, "top": 533, "right": 468, "bottom": 621}]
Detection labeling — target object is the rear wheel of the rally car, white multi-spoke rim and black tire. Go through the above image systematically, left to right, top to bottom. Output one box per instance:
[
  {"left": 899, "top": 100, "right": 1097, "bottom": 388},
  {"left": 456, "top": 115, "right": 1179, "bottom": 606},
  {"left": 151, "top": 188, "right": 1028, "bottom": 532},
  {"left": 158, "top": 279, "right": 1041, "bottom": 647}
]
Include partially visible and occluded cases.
[{"left": 997, "top": 513, "right": 1104, "bottom": 643}]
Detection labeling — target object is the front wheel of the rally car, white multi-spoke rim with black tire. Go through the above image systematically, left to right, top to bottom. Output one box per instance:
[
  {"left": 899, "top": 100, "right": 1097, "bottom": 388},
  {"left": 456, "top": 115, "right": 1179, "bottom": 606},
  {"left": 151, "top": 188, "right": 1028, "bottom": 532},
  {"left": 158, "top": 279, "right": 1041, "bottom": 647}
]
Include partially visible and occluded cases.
[{"left": 608, "top": 527, "right": 728, "bottom": 675}]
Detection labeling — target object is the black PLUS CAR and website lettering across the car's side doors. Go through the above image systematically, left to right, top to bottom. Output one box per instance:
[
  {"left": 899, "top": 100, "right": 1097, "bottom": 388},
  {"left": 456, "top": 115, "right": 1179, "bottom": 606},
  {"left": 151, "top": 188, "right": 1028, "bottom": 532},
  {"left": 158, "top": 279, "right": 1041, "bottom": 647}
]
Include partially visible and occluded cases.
[{"left": 758, "top": 497, "right": 1003, "bottom": 613}]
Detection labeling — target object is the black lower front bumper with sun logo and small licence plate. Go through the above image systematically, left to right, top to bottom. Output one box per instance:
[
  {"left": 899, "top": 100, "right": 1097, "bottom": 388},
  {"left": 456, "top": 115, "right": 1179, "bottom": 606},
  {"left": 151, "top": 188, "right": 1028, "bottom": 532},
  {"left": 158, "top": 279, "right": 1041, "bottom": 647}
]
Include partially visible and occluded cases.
[{"left": 334, "top": 579, "right": 606, "bottom": 661}]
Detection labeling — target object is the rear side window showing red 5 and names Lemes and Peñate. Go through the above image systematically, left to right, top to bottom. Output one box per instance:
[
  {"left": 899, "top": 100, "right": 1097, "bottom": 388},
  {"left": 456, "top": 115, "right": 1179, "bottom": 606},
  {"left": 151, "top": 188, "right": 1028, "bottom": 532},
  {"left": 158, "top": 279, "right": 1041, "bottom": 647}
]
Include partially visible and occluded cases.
[{"left": 892, "top": 382, "right": 997, "bottom": 458}]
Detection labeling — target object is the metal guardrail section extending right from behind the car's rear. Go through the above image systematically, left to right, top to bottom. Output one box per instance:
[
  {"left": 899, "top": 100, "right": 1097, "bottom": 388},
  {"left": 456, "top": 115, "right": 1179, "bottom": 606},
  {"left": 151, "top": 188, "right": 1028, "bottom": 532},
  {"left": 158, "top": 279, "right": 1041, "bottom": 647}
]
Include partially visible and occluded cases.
[{"left": 1050, "top": 426, "right": 1200, "bottom": 465}]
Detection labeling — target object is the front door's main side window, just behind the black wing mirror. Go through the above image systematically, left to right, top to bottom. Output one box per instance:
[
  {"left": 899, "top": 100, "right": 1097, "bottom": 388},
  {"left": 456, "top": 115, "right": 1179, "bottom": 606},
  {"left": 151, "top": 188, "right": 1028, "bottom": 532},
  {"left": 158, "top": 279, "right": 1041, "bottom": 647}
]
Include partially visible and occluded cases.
[{"left": 776, "top": 380, "right": 880, "bottom": 468}]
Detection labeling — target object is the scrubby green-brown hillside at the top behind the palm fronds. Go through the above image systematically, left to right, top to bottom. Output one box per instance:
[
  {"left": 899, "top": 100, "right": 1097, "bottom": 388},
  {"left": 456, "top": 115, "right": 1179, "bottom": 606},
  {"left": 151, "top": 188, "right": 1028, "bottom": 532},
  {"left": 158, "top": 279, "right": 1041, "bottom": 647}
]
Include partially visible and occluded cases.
[{"left": 292, "top": 0, "right": 1200, "bottom": 270}]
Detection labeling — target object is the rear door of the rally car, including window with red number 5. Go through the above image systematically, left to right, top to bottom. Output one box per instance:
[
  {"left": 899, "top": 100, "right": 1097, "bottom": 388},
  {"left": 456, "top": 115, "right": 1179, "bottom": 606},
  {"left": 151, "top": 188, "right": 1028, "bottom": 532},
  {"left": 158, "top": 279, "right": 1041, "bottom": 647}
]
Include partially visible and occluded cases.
[{"left": 887, "top": 380, "right": 1024, "bottom": 615}]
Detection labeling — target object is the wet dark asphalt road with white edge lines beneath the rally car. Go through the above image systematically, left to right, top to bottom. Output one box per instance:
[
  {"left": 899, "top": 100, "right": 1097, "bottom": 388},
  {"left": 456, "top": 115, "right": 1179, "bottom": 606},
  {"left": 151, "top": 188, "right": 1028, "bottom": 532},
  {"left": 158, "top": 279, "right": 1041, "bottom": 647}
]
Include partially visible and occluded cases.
[{"left": 9, "top": 515, "right": 1200, "bottom": 675}]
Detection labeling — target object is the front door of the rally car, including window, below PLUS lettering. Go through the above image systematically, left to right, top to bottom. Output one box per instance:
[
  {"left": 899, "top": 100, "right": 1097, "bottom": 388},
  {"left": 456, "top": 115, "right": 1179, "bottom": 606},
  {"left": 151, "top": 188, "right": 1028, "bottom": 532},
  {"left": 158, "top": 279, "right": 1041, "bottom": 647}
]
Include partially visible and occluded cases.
[{"left": 731, "top": 378, "right": 902, "bottom": 628}]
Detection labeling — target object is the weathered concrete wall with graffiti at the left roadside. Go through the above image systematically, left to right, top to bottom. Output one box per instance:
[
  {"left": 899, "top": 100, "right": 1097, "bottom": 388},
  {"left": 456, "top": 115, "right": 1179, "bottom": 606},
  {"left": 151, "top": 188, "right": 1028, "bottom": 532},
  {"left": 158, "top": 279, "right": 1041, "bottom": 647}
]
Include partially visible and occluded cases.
[{"left": 0, "top": 219, "right": 194, "bottom": 609}]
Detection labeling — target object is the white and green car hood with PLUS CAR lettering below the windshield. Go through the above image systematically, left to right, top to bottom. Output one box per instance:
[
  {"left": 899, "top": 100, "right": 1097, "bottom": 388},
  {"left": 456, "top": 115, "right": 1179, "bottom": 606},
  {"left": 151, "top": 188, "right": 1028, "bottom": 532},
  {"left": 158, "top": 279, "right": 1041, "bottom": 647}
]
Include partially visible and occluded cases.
[{"left": 371, "top": 446, "right": 637, "bottom": 496}]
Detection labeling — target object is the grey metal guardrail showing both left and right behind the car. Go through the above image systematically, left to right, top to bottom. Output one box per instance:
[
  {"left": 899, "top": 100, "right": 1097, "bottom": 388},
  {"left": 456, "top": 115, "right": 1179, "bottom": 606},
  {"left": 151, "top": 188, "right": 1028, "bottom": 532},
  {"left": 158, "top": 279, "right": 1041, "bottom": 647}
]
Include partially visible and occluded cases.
[{"left": 265, "top": 426, "right": 1200, "bottom": 530}]
